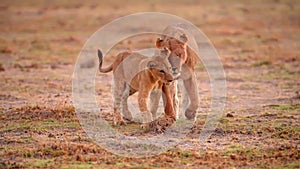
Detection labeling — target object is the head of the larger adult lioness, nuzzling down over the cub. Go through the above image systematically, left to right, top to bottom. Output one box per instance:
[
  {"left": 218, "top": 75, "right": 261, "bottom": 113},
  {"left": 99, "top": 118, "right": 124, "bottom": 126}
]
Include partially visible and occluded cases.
[{"left": 156, "top": 34, "right": 188, "bottom": 76}]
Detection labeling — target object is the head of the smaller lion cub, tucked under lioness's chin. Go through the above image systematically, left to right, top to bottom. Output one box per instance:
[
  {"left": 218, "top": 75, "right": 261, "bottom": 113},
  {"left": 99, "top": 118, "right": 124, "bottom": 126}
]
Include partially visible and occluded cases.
[{"left": 147, "top": 49, "right": 174, "bottom": 84}]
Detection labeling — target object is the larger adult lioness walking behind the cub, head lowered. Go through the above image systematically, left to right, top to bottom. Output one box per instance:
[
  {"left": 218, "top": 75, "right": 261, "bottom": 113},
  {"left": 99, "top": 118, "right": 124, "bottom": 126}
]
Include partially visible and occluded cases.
[{"left": 156, "top": 24, "right": 199, "bottom": 120}]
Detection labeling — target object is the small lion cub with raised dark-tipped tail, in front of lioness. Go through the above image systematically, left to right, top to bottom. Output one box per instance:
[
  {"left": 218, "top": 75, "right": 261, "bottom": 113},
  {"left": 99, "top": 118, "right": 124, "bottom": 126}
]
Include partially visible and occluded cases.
[{"left": 98, "top": 50, "right": 174, "bottom": 125}]
